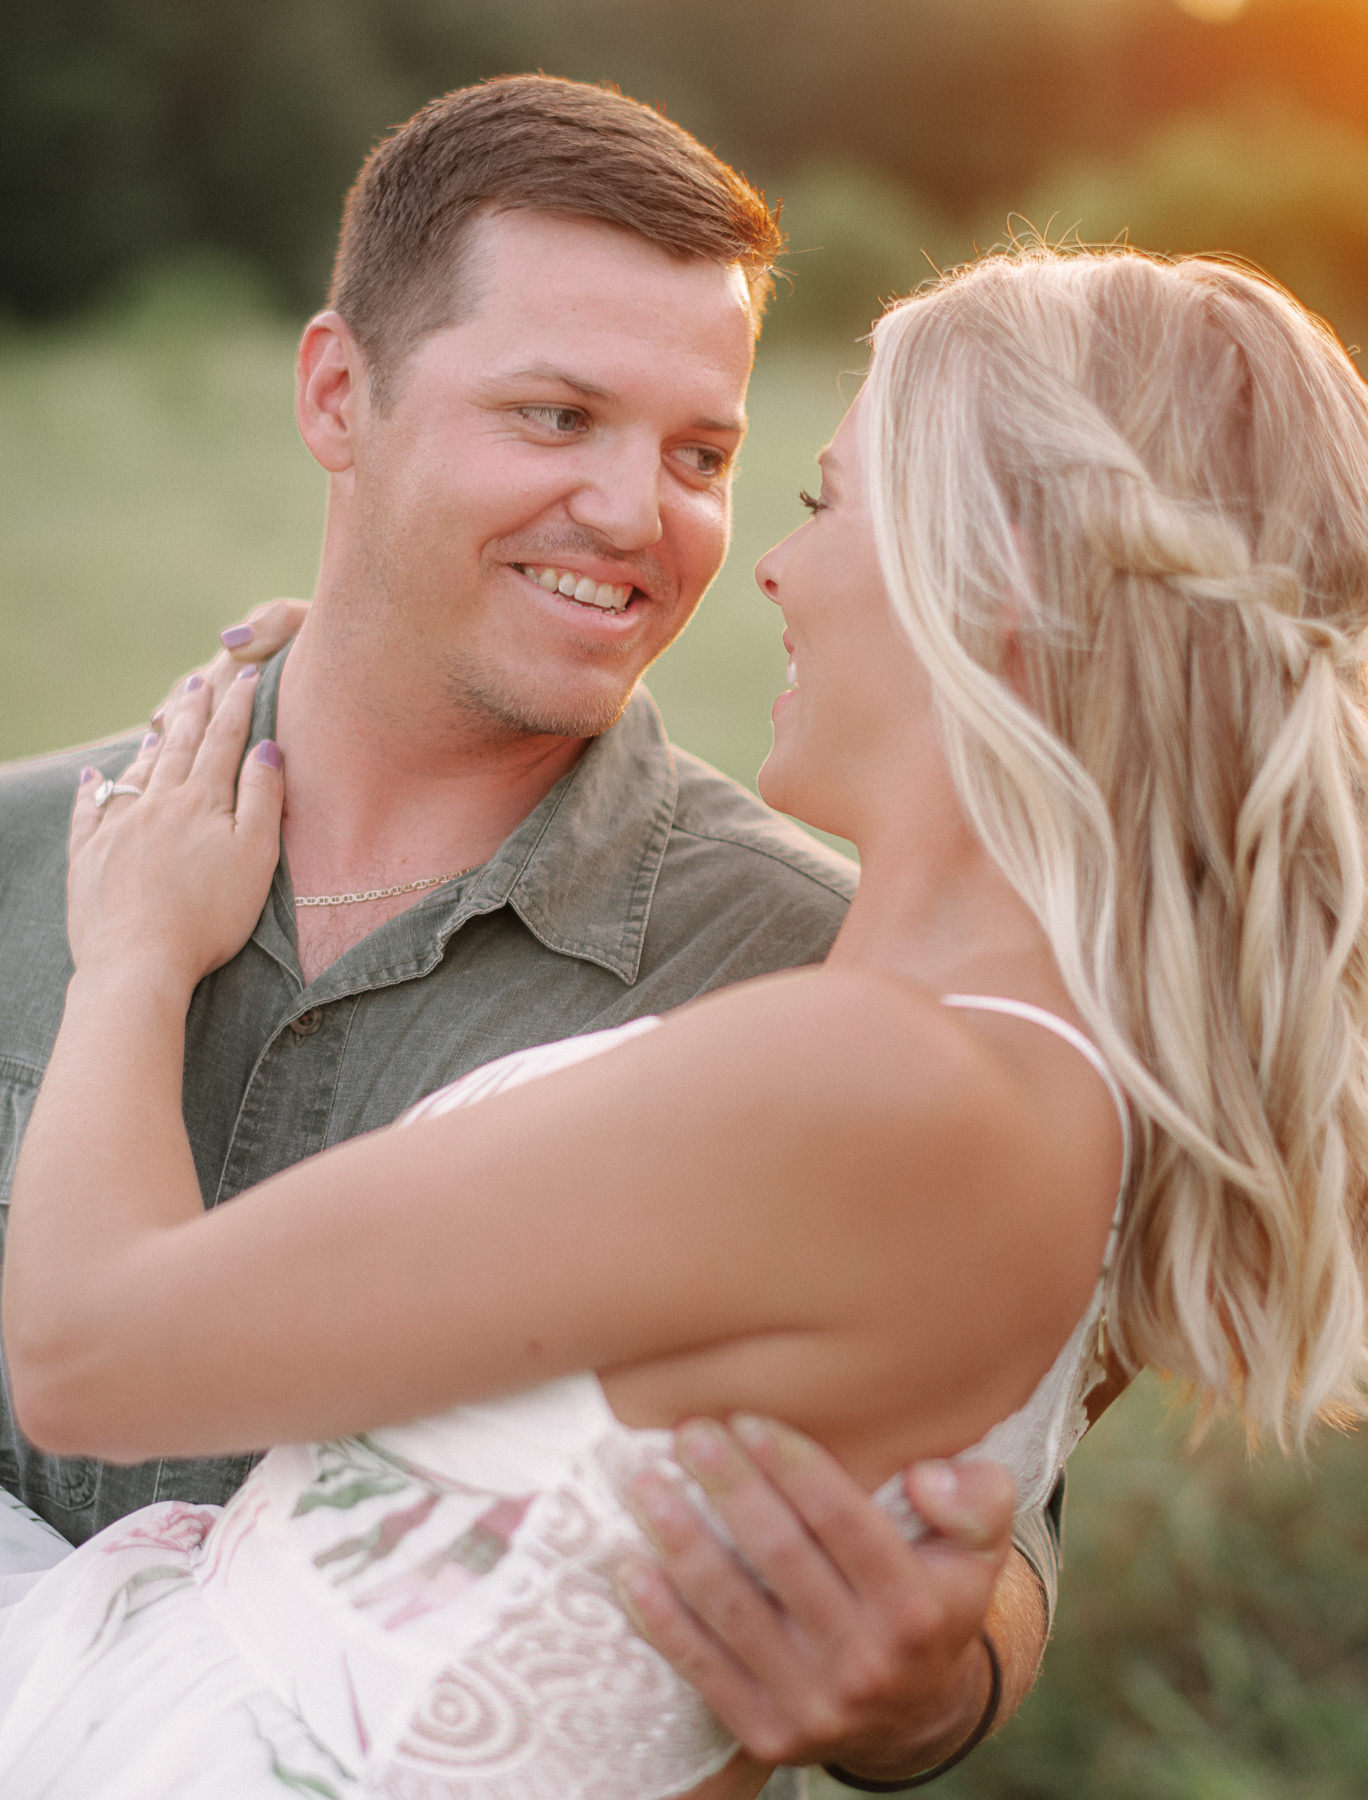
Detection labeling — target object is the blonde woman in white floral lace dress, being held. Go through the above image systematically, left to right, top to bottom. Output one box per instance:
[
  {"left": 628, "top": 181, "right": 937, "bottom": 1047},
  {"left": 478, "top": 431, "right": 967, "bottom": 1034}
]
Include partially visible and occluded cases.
[{"left": 0, "top": 250, "right": 1368, "bottom": 1800}]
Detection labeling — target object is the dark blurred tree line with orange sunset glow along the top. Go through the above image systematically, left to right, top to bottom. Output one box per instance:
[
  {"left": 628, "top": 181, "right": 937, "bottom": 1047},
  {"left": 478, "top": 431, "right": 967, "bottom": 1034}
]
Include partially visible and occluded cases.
[{"left": 0, "top": 0, "right": 1368, "bottom": 326}]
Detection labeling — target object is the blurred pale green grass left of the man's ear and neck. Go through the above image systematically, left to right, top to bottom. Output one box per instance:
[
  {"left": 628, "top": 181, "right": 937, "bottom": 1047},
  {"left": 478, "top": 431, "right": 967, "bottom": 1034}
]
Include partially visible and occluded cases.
[{"left": 0, "top": 252, "right": 324, "bottom": 758}]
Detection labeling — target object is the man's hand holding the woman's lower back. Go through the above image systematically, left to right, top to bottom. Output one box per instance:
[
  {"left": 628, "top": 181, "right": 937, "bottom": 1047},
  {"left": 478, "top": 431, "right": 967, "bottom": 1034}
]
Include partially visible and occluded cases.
[{"left": 619, "top": 1418, "right": 1044, "bottom": 1780}]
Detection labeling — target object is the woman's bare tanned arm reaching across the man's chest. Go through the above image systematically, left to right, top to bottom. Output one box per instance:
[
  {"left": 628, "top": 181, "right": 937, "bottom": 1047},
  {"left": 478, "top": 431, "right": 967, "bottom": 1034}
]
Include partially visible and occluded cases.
[{"left": 5, "top": 958, "right": 1089, "bottom": 1474}]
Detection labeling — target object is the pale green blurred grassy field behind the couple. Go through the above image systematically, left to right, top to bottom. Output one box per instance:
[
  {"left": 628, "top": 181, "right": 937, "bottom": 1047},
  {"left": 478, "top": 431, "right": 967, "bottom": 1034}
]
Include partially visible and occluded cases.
[{"left": 0, "top": 268, "right": 1368, "bottom": 1800}]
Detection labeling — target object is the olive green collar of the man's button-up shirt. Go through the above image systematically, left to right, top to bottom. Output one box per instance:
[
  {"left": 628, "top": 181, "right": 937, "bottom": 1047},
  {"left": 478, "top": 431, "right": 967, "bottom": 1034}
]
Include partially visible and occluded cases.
[{"left": 252, "top": 655, "right": 679, "bottom": 986}]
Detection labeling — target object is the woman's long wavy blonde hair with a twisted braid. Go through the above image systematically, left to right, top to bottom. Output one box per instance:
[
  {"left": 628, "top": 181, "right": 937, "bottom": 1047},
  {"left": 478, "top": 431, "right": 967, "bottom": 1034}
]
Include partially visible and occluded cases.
[{"left": 860, "top": 247, "right": 1368, "bottom": 1445}]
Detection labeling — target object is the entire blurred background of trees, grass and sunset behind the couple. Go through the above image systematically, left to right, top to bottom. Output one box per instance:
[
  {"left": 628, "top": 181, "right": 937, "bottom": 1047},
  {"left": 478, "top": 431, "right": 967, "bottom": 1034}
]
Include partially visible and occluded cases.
[{"left": 0, "top": 0, "right": 1368, "bottom": 1800}]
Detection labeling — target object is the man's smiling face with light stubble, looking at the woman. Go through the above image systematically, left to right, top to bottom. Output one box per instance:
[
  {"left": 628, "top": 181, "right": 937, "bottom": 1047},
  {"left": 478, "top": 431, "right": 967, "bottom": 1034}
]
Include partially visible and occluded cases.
[{"left": 334, "top": 212, "right": 752, "bottom": 738}]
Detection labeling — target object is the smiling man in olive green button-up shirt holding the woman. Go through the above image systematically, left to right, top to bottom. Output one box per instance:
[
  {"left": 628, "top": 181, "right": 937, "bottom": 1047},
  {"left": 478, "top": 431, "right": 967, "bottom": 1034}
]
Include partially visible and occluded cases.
[{"left": 0, "top": 77, "right": 1044, "bottom": 1795}]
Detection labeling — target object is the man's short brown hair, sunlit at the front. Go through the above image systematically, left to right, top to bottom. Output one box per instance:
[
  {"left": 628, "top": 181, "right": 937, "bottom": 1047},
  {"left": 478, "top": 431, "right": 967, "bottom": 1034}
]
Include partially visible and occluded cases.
[{"left": 329, "top": 76, "right": 783, "bottom": 407}]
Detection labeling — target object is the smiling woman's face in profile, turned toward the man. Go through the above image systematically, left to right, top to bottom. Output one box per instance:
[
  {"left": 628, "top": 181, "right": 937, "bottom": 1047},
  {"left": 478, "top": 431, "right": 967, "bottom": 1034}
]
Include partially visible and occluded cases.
[{"left": 756, "top": 398, "right": 931, "bottom": 841}]
